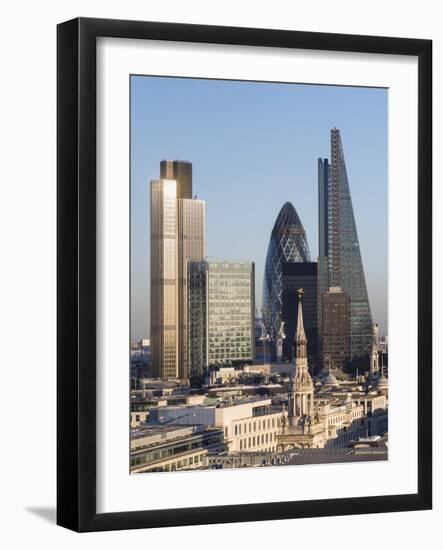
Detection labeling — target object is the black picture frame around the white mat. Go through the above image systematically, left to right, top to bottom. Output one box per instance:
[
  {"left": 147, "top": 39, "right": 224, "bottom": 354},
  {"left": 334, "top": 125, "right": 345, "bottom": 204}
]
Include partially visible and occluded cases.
[{"left": 57, "top": 18, "right": 432, "bottom": 532}]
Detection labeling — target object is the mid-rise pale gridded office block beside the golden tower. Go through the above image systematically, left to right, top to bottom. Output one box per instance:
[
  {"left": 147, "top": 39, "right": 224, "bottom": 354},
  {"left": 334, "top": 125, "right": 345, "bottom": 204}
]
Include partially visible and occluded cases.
[{"left": 188, "top": 260, "right": 255, "bottom": 376}]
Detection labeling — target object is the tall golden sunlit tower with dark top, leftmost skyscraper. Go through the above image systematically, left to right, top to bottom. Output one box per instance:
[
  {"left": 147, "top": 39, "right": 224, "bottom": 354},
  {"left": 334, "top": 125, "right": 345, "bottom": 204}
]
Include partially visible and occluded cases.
[{"left": 151, "top": 161, "right": 205, "bottom": 378}]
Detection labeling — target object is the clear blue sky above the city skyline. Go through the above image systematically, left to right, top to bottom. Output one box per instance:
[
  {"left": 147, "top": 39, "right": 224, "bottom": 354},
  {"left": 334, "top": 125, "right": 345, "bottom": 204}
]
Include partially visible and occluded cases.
[{"left": 131, "top": 76, "right": 388, "bottom": 340}]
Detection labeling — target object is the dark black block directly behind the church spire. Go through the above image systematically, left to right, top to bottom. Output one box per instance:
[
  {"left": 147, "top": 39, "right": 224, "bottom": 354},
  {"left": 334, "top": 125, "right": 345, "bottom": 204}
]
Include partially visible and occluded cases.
[{"left": 282, "top": 262, "right": 318, "bottom": 373}]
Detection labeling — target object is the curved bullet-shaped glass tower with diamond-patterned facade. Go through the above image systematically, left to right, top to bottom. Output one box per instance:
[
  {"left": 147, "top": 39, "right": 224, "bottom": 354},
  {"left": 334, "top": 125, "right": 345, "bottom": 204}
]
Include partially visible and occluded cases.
[{"left": 262, "top": 202, "right": 311, "bottom": 348}]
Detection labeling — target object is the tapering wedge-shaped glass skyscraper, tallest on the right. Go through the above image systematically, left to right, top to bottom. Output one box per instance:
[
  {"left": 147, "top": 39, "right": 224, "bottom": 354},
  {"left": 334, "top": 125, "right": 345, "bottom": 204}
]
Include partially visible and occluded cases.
[{"left": 318, "top": 128, "right": 372, "bottom": 360}]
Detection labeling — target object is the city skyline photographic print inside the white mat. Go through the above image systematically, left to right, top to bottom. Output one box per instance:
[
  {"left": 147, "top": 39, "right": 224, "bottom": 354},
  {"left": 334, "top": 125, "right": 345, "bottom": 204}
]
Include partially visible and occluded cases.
[{"left": 129, "top": 75, "right": 389, "bottom": 474}]
